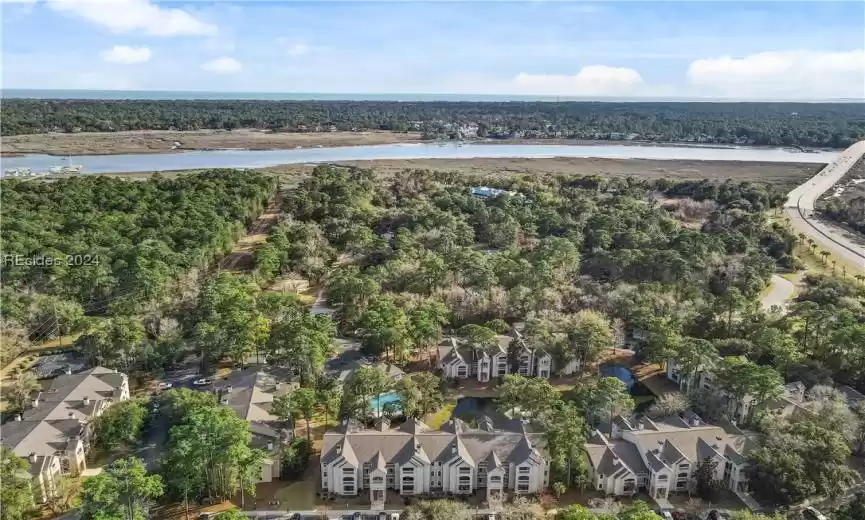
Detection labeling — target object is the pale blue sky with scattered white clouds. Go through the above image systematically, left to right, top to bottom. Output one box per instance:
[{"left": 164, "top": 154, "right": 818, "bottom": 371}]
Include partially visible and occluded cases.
[{"left": 0, "top": 0, "right": 865, "bottom": 100}]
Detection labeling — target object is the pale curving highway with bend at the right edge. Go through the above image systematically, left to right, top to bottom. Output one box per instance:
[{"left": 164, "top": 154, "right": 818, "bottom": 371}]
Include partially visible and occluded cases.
[{"left": 784, "top": 141, "right": 865, "bottom": 270}]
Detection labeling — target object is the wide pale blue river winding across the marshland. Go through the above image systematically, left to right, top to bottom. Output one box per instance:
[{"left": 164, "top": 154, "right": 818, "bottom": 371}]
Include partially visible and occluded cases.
[{"left": 2, "top": 143, "right": 840, "bottom": 173}]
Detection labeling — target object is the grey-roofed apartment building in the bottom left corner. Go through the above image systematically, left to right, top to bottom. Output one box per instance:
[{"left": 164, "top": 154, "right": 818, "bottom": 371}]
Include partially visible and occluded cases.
[{"left": 2, "top": 367, "right": 129, "bottom": 503}]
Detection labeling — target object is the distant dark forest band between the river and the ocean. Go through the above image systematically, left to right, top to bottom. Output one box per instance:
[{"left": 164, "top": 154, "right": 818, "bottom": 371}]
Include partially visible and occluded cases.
[{"left": 0, "top": 99, "right": 865, "bottom": 148}]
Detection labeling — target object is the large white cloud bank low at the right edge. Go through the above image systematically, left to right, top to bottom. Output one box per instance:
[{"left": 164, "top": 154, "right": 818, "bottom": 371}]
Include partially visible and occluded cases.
[{"left": 687, "top": 49, "right": 865, "bottom": 99}]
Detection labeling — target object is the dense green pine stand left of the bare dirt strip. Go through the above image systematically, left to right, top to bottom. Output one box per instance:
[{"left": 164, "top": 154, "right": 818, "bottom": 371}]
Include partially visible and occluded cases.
[{"left": 0, "top": 170, "right": 275, "bottom": 360}]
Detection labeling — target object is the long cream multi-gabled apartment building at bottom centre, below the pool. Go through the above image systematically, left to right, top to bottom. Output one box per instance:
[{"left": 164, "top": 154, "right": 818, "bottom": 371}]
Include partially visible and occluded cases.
[{"left": 321, "top": 416, "right": 550, "bottom": 510}]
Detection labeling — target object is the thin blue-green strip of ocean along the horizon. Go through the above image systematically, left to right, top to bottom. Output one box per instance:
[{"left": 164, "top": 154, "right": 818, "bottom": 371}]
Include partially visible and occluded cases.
[{"left": 0, "top": 88, "right": 865, "bottom": 103}]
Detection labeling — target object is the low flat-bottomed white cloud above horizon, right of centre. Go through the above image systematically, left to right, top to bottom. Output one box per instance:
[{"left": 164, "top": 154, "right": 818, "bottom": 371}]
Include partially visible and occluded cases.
[{"left": 511, "top": 65, "right": 645, "bottom": 96}]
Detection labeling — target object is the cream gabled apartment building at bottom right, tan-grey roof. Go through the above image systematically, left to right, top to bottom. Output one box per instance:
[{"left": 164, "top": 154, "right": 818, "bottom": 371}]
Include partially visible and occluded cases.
[{"left": 585, "top": 414, "right": 756, "bottom": 500}]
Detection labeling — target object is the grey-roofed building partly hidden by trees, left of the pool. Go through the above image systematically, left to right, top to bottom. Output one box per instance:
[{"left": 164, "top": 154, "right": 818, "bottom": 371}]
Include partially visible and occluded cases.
[{"left": 213, "top": 368, "right": 297, "bottom": 482}]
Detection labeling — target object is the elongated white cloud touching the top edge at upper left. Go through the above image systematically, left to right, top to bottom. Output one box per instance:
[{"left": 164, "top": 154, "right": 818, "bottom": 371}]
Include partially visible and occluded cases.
[{"left": 47, "top": 0, "right": 217, "bottom": 36}]
